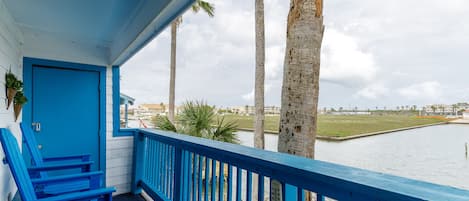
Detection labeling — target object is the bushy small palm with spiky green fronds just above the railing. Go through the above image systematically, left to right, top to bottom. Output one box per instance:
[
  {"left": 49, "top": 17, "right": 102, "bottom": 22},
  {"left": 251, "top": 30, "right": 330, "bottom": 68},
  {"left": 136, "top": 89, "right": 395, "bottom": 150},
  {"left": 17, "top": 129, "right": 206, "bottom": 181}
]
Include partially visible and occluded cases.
[{"left": 155, "top": 101, "right": 239, "bottom": 143}]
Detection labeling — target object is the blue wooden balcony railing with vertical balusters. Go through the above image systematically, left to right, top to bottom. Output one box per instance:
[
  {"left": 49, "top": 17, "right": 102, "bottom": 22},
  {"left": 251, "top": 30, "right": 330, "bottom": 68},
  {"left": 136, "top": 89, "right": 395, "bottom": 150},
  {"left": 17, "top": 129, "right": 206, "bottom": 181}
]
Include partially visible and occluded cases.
[{"left": 132, "top": 129, "right": 469, "bottom": 201}]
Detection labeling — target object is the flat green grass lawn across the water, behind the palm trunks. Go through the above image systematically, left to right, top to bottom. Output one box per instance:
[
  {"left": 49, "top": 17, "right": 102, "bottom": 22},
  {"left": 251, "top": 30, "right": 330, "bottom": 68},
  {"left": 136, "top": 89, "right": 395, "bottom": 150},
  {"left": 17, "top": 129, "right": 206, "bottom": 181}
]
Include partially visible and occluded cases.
[{"left": 220, "top": 115, "right": 446, "bottom": 137}]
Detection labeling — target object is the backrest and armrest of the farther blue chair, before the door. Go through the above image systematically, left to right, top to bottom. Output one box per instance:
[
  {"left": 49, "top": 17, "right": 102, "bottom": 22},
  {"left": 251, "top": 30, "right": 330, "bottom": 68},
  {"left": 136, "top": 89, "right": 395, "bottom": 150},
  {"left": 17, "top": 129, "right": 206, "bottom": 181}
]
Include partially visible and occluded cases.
[{"left": 20, "top": 123, "right": 93, "bottom": 178}]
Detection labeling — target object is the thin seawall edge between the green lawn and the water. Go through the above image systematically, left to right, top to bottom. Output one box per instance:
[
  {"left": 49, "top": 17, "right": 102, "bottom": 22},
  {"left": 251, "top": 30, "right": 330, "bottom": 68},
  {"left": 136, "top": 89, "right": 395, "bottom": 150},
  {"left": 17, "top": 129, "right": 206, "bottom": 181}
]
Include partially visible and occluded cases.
[{"left": 238, "top": 122, "right": 451, "bottom": 141}]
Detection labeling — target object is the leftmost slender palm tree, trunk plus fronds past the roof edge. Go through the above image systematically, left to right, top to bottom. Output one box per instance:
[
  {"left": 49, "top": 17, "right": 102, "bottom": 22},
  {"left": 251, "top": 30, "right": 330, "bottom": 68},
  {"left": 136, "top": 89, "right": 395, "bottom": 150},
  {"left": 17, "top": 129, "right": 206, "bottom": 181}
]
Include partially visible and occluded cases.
[{"left": 168, "top": 0, "right": 215, "bottom": 122}]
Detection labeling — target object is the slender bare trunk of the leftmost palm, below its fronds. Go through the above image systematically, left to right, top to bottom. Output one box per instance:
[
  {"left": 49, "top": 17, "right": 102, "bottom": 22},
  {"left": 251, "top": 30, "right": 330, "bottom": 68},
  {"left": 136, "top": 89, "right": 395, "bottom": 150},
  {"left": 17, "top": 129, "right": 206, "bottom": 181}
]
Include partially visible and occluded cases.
[{"left": 168, "top": 19, "right": 179, "bottom": 124}]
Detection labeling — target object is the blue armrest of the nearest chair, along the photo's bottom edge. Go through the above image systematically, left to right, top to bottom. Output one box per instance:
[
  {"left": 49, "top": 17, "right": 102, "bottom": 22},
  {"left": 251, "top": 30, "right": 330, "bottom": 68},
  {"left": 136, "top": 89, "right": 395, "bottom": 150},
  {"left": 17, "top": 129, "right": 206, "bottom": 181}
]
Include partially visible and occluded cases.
[{"left": 38, "top": 188, "right": 116, "bottom": 201}]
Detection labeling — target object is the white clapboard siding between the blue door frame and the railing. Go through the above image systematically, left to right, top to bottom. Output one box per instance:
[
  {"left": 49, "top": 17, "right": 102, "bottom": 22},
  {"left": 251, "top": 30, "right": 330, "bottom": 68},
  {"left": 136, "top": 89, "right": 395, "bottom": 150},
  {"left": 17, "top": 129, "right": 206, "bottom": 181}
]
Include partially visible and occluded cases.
[{"left": 106, "top": 66, "right": 133, "bottom": 194}]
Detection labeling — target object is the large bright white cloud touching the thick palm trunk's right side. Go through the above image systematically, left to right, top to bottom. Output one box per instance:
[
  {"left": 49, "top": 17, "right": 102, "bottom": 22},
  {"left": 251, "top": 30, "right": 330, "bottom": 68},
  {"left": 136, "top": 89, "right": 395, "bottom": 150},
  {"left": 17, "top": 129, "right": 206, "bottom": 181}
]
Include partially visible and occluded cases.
[{"left": 321, "top": 28, "right": 378, "bottom": 85}]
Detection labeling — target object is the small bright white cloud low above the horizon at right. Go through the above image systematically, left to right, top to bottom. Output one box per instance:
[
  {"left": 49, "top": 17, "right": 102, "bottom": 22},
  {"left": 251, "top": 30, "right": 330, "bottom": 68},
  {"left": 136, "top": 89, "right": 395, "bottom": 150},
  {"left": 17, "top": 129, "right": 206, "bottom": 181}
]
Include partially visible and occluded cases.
[{"left": 397, "top": 81, "right": 442, "bottom": 101}]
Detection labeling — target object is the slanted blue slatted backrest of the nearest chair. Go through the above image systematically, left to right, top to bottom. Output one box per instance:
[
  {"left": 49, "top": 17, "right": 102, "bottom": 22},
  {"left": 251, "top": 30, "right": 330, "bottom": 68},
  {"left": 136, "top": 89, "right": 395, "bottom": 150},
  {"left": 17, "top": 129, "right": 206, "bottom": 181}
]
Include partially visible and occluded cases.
[{"left": 0, "top": 128, "right": 37, "bottom": 201}]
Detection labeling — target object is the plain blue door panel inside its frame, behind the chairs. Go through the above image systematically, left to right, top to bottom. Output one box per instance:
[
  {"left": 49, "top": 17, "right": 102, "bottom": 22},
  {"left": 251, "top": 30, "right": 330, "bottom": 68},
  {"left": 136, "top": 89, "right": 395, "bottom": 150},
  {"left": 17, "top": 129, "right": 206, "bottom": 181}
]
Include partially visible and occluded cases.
[{"left": 31, "top": 66, "right": 100, "bottom": 170}]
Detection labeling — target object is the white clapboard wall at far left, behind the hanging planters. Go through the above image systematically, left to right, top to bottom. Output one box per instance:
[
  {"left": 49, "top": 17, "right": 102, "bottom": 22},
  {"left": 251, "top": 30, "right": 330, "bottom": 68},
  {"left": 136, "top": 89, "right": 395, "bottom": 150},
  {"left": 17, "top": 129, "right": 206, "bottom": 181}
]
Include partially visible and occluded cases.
[{"left": 0, "top": 1, "right": 23, "bottom": 201}]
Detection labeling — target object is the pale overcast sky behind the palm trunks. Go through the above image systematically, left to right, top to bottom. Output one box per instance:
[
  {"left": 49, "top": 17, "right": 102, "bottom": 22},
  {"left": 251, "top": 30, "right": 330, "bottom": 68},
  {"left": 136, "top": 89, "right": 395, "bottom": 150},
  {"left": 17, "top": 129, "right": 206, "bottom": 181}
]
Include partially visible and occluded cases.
[{"left": 121, "top": 0, "right": 469, "bottom": 109}]
